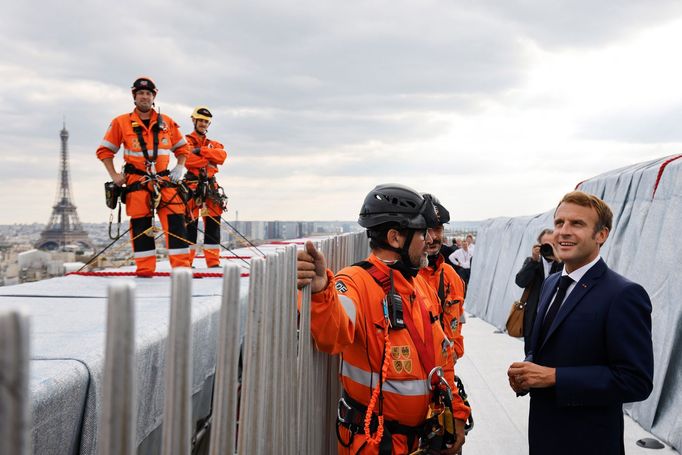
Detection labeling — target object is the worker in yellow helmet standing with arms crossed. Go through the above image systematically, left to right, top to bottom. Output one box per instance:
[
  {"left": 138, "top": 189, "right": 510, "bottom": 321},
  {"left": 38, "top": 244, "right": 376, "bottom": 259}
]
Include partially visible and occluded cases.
[{"left": 185, "top": 106, "right": 227, "bottom": 267}]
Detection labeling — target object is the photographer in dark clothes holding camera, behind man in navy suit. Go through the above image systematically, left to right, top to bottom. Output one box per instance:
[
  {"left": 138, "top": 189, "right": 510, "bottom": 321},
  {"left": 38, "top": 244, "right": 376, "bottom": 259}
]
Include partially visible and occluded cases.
[{"left": 516, "top": 229, "right": 563, "bottom": 355}]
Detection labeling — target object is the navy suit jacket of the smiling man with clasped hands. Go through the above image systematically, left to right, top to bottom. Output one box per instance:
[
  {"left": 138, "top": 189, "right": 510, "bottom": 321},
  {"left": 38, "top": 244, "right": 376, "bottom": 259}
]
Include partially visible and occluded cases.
[{"left": 527, "top": 259, "right": 654, "bottom": 455}]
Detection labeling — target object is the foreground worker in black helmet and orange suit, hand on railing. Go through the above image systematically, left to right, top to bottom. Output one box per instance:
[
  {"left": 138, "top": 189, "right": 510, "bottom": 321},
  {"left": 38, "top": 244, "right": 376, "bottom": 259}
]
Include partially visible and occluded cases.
[{"left": 297, "top": 184, "right": 470, "bottom": 455}]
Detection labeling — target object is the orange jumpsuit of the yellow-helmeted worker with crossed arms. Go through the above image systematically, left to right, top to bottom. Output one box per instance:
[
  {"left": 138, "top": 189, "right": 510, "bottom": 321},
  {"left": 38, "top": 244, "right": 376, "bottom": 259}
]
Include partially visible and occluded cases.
[{"left": 185, "top": 131, "right": 227, "bottom": 267}]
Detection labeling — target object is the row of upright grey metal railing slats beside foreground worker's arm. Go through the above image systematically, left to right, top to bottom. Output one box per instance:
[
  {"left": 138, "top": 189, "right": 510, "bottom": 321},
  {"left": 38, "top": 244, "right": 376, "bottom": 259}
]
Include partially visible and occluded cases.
[{"left": 94, "top": 233, "right": 368, "bottom": 455}]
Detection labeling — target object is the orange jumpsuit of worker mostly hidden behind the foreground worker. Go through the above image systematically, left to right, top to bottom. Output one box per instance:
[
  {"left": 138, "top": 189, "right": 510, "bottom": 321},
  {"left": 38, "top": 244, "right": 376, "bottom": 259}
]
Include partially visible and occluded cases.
[{"left": 419, "top": 253, "right": 464, "bottom": 360}]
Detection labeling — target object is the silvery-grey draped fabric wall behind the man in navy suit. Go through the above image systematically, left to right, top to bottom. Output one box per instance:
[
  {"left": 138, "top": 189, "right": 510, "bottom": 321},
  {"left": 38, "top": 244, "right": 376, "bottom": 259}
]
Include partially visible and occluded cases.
[{"left": 466, "top": 157, "right": 682, "bottom": 450}]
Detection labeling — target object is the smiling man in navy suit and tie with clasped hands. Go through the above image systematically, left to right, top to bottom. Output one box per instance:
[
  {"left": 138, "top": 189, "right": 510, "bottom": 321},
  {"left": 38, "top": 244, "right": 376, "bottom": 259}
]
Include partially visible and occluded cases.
[{"left": 508, "top": 191, "right": 653, "bottom": 455}]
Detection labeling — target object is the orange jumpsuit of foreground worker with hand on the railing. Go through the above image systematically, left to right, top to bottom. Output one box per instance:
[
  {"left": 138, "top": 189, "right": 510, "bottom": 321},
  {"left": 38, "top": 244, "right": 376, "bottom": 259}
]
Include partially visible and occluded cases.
[{"left": 311, "top": 255, "right": 470, "bottom": 454}]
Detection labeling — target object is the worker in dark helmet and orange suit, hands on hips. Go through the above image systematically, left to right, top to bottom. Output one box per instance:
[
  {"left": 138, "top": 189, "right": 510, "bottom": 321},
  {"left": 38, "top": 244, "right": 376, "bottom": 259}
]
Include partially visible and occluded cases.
[{"left": 97, "top": 77, "right": 189, "bottom": 277}]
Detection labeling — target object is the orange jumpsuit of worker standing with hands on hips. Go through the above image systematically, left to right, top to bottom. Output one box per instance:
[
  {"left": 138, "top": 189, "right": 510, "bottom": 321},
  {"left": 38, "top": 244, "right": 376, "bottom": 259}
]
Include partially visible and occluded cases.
[{"left": 97, "top": 110, "right": 190, "bottom": 275}]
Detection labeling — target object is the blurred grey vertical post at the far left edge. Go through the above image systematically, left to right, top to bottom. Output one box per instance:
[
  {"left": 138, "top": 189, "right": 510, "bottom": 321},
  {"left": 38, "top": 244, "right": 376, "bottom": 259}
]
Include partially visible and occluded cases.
[{"left": 0, "top": 311, "right": 31, "bottom": 455}]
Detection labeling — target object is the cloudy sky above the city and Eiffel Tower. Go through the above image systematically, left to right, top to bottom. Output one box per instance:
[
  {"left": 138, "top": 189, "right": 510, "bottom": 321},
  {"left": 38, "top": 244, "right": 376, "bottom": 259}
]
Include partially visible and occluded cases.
[{"left": 0, "top": 0, "right": 682, "bottom": 224}]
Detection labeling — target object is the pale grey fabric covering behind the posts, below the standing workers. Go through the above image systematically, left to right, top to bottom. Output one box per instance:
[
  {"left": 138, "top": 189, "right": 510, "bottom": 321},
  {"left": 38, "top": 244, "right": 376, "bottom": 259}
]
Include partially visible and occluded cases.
[{"left": 0, "top": 268, "right": 248, "bottom": 455}]
